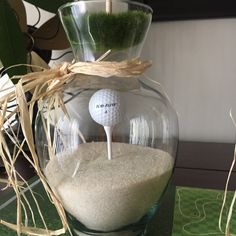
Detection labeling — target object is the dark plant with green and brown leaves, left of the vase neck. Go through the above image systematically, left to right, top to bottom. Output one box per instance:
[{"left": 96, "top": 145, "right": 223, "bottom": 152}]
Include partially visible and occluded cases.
[{"left": 0, "top": 0, "right": 72, "bottom": 82}]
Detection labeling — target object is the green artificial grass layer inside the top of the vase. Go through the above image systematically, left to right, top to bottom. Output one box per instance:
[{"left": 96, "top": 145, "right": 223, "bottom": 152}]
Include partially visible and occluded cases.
[{"left": 63, "top": 10, "right": 151, "bottom": 52}]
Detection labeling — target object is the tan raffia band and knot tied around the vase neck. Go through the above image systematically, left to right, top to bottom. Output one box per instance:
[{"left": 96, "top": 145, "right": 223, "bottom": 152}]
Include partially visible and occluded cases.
[{"left": 0, "top": 58, "right": 152, "bottom": 105}]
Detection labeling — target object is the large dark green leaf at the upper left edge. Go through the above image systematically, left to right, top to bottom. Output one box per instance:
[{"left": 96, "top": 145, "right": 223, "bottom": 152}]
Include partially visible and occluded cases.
[{"left": 0, "top": 0, "right": 27, "bottom": 79}]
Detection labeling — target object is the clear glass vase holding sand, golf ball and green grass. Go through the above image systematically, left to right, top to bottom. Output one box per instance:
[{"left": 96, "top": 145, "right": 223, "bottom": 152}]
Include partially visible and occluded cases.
[{"left": 36, "top": 0, "right": 178, "bottom": 236}]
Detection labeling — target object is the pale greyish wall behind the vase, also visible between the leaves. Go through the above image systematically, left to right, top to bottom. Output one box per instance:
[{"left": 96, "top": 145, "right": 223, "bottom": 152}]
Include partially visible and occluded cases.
[{"left": 13, "top": 0, "right": 236, "bottom": 143}]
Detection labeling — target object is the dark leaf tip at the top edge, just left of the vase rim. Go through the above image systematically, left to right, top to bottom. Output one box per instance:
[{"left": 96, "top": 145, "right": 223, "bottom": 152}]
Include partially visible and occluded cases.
[{"left": 26, "top": 0, "right": 73, "bottom": 13}]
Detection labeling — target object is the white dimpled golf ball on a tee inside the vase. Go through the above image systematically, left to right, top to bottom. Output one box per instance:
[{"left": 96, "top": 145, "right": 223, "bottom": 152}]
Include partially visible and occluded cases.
[{"left": 89, "top": 89, "right": 122, "bottom": 127}]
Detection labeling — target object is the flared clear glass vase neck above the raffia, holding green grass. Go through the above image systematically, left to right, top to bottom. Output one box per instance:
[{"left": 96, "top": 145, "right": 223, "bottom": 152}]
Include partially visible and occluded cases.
[{"left": 59, "top": 0, "right": 152, "bottom": 61}]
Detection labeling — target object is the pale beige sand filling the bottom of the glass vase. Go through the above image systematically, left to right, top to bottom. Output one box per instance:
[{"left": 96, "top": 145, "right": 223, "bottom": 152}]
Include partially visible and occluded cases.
[{"left": 45, "top": 142, "right": 173, "bottom": 231}]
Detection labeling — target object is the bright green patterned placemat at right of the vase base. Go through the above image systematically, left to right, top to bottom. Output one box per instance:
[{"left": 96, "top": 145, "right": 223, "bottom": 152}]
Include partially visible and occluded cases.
[{"left": 172, "top": 187, "right": 236, "bottom": 236}]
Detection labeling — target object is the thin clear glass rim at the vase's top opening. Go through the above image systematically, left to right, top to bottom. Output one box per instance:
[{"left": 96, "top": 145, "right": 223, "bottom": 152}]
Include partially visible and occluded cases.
[{"left": 58, "top": 0, "right": 153, "bottom": 14}]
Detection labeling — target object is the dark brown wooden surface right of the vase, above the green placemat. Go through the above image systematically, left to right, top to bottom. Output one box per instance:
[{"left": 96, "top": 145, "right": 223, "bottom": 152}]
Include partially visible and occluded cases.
[{"left": 174, "top": 141, "right": 236, "bottom": 189}]
